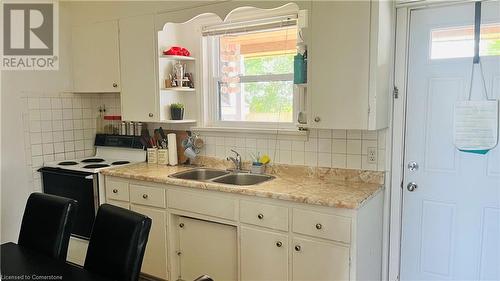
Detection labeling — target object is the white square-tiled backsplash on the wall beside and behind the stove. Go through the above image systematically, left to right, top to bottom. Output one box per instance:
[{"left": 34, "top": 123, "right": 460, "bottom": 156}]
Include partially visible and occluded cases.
[{"left": 21, "top": 93, "right": 120, "bottom": 190}]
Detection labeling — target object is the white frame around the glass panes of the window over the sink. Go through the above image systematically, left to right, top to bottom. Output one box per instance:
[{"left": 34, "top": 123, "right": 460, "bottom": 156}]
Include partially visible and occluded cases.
[{"left": 203, "top": 25, "right": 299, "bottom": 130}]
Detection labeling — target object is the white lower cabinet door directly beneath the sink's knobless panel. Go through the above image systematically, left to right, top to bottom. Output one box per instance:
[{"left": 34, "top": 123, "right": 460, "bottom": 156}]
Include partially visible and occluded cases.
[{"left": 177, "top": 217, "right": 238, "bottom": 280}]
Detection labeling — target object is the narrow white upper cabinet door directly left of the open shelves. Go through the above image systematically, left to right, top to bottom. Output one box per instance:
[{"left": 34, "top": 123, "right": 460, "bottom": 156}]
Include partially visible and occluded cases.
[{"left": 120, "top": 15, "right": 159, "bottom": 122}]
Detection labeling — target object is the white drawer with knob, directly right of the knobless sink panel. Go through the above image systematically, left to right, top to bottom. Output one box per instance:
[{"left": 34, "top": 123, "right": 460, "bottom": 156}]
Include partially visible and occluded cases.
[{"left": 240, "top": 200, "right": 288, "bottom": 231}]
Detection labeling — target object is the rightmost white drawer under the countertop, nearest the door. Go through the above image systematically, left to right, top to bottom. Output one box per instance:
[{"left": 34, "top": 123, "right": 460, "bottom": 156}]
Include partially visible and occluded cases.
[{"left": 293, "top": 209, "right": 351, "bottom": 243}]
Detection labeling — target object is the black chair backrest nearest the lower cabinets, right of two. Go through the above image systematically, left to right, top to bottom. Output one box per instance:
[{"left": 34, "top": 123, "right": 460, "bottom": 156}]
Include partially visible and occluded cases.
[{"left": 83, "top": 204, "right": 151, "bottom": 281}]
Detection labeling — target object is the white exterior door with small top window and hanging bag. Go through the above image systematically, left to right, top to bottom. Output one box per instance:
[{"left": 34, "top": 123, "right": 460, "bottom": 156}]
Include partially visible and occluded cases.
[{"left": 400, "top": 2, "right": 500, "bottom": 280}]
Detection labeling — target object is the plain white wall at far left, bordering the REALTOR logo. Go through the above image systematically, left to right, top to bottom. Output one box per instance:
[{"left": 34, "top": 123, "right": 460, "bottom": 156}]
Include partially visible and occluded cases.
[{"left": 0, "top": 3, "right": 71, "bottom": 243}]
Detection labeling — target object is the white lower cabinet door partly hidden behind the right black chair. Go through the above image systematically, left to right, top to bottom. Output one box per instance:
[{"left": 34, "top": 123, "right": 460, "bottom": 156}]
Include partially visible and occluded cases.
[{"left": 131, "top": 204, "right": 167, "bottom": 279}]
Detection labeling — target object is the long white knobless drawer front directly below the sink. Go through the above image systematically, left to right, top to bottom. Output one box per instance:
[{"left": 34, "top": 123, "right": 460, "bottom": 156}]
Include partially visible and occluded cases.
[{"left": 168, "top": 190, "right": 236, "bottom": 221}]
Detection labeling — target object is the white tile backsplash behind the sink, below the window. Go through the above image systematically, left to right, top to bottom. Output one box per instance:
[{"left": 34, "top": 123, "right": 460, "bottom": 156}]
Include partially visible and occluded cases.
[{"left": 196, "top": 129, "right": 387, "bottom": 171}]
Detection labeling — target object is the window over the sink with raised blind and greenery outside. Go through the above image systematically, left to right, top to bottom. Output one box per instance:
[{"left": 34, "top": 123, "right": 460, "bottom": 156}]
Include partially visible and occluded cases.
[{"left": 203, "top": 15, "right": 298, "bottom": 128}]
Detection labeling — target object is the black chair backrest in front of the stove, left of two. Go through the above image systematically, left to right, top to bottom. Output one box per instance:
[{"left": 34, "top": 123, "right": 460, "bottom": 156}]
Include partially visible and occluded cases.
[{"left": 17, "top": 193, "right": 77, "bottom": 260}]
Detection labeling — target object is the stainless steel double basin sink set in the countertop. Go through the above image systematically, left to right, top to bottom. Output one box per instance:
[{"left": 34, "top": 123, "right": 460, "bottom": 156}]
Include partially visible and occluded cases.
[{"left": 170, "top": 168, "right": 274, "bottom": 185}]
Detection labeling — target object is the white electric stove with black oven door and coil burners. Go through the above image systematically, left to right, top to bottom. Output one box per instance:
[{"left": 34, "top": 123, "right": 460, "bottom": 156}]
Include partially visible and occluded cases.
[{"left": 39, "top": 134, "right": 146, "bottom": 264}]
